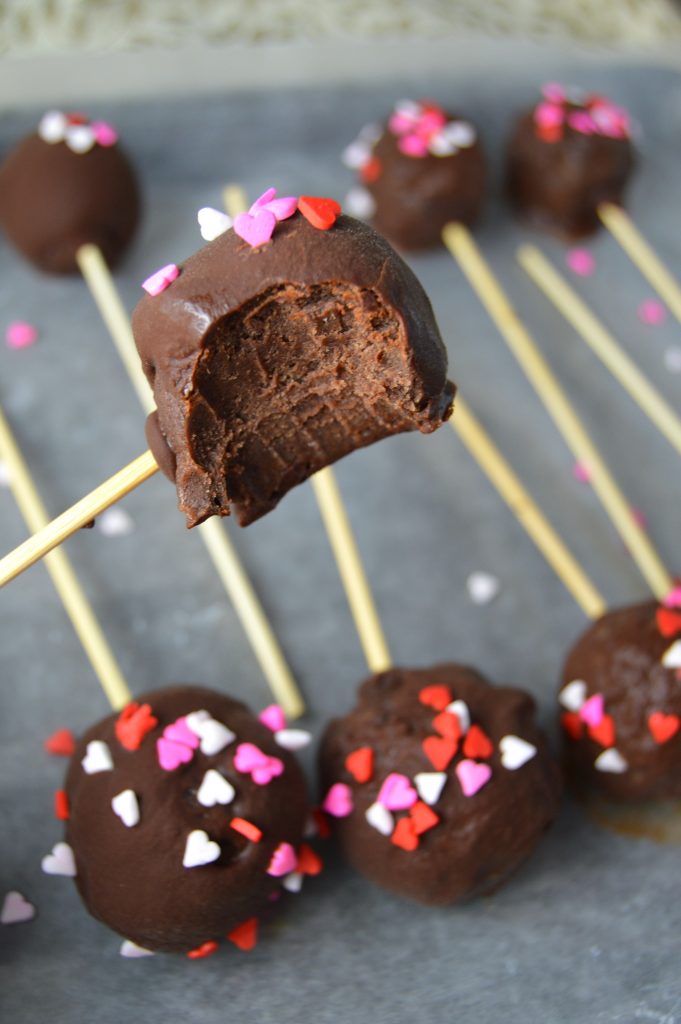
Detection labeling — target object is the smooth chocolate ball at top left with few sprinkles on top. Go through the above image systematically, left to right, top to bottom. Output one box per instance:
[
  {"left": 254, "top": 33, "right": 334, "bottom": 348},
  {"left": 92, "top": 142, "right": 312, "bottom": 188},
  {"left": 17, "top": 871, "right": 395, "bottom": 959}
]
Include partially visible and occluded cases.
[{"left": 0, "top": 111, "right": 139, "bottom": 273}]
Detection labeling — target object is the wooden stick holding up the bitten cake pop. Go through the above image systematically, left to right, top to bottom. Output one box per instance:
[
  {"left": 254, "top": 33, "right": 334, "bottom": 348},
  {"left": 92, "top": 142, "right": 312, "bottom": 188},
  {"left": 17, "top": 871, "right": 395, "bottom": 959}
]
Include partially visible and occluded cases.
[{"left": 0, "top": 452, "right": 159, "bottom": 587}]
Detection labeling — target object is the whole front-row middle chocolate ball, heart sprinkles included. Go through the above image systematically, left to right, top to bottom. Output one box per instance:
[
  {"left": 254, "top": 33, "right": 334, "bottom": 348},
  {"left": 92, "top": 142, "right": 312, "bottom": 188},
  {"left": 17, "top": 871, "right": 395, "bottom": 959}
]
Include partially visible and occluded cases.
[{"left": 320, "top": 665, "right": 560, "bottom": 904}]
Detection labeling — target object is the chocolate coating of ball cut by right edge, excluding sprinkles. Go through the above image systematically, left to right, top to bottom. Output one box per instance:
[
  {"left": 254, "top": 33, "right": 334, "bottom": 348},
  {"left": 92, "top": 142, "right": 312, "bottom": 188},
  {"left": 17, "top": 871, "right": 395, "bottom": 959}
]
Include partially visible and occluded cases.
[{"left": 561, "top": 601, "right": 681, "bottom": 801}]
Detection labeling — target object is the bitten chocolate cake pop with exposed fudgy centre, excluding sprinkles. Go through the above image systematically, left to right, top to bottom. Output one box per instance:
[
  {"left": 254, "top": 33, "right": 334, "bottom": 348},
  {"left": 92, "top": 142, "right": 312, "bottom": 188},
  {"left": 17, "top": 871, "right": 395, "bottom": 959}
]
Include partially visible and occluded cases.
[{"left": 132, "top": 213, "right": 454, "bottom": 526}]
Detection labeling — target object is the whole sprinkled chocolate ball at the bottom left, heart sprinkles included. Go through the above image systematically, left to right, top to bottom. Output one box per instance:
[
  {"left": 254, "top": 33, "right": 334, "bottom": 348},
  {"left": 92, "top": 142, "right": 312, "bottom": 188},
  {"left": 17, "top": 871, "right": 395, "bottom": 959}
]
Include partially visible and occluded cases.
[{"left": 59, "top": 686, "right": 307, "bottom": 955}]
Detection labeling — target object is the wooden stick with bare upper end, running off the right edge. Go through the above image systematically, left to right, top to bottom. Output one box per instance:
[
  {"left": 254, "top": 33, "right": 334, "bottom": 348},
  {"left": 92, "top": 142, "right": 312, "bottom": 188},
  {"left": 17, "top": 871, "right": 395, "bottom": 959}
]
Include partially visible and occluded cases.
[{"left": 517, "top": 246, "right": 681, "bottom": 455}]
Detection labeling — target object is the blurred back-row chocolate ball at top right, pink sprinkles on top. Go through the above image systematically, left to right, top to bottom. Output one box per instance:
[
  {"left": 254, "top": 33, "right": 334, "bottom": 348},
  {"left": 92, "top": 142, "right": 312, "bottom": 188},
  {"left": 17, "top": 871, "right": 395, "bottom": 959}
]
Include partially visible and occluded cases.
[{"left": 507, "top": 84, "right": 634, "bottom": 239}]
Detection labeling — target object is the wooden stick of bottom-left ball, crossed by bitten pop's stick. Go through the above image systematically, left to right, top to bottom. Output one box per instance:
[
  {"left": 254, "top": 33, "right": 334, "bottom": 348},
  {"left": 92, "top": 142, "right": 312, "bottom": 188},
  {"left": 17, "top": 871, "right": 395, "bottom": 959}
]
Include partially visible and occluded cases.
[{"left": 0, "top": 410, "right": 131, "bottom": 710}]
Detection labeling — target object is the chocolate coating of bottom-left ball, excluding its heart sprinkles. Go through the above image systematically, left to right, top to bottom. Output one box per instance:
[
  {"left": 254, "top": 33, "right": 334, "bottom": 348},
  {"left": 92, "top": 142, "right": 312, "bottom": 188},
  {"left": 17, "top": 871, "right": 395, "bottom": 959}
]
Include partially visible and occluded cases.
[{"left": 66, "top": 686, "right": 307, "bottom": 952}]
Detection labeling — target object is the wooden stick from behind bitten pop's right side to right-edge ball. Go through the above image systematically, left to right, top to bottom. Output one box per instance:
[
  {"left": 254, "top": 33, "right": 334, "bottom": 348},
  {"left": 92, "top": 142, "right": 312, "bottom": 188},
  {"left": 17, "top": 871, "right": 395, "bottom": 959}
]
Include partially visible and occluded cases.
[{"left": 450, "top": 395, "right": 607, "bottom": 618}]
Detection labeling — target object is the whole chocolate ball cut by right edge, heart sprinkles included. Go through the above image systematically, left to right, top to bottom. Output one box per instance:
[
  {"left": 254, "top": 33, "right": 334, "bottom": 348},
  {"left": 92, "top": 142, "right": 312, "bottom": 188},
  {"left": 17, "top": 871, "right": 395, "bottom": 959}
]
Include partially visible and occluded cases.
[{"left": 558, "top": 601, "right": 681, "bottom": 800}]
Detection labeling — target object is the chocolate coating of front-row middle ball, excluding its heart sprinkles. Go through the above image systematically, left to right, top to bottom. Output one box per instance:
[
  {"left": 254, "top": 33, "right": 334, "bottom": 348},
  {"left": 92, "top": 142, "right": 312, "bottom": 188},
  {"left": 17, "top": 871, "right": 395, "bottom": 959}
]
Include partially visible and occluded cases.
[{"left": 320, "top": 665, "right": 561, "bottom": 904}]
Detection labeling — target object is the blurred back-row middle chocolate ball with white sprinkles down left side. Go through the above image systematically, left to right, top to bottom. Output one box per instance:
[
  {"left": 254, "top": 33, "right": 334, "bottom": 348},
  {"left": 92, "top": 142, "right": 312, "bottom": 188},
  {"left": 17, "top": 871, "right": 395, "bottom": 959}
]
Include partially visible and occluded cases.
[{"left": 343, "top": 100, "right": 486, "bottom": 250}]
